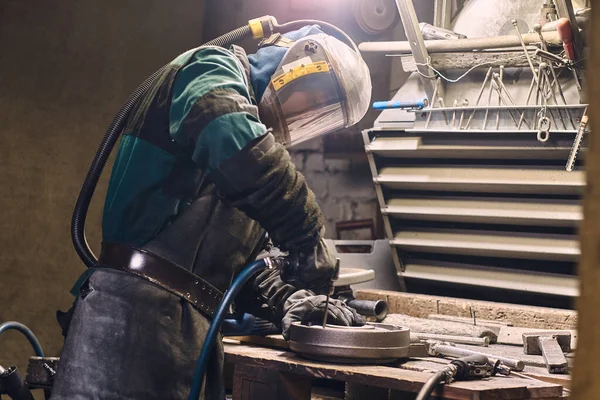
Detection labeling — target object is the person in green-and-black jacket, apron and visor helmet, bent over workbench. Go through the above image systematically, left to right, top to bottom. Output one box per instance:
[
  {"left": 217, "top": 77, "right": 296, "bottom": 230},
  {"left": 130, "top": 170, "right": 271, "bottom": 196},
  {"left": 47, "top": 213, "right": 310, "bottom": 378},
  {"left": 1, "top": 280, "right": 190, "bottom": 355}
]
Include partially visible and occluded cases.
[{"left": 52, "top": 26, "right": 371, "bottom": 400}]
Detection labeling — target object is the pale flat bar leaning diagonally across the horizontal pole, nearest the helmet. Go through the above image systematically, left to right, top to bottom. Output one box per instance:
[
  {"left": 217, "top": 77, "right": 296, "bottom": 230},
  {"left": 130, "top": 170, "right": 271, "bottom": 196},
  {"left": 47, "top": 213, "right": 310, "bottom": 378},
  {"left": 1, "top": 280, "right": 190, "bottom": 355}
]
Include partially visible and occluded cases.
[{"left": 396, "top": 0, "right": 436, "bottom": 102}]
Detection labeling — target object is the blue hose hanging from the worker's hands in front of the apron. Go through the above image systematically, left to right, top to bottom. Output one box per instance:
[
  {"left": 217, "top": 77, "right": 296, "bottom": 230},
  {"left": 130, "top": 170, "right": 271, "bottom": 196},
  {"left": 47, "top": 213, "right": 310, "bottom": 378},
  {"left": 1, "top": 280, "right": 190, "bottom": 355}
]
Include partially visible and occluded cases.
[{"left": 188, "top": 257, "right": 274, "bottom": 400}]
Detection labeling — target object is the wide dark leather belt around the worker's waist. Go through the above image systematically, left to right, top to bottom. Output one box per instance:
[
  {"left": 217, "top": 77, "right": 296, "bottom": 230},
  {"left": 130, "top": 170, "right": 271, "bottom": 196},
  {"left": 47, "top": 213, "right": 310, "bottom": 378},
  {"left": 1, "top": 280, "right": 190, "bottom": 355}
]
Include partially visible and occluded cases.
[{"left": 98, "top": 243, "right": 223, "bottom": 318}]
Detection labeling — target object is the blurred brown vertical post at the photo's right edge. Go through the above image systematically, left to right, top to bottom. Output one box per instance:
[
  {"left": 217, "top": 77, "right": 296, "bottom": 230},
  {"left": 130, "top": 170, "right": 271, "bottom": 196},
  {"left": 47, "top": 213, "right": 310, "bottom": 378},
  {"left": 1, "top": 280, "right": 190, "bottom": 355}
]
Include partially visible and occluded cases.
[{"left": 572, "top": 4, "right": 600, "bottom": 400}]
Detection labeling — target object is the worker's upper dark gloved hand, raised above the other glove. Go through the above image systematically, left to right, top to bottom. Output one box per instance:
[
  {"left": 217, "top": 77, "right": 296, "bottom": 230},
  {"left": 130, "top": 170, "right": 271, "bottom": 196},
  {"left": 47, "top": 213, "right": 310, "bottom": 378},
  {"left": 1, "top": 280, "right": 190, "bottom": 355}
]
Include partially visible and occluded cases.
[{"left": 281, "top": 239, "right": 337, "bottom": 294}]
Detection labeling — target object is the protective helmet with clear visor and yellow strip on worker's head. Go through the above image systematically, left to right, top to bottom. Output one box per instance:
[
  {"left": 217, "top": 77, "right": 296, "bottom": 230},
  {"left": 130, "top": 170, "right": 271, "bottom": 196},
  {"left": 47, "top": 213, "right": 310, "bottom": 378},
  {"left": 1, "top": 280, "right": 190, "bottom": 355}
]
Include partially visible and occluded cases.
[{"left": 259, "top": 33, "right": 371, "bottom": 146}]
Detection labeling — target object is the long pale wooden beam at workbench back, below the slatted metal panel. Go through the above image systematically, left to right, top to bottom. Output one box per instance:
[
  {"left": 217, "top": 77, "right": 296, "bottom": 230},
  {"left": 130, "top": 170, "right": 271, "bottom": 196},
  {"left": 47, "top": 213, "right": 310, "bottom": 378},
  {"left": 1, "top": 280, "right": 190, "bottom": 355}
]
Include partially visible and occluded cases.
[{"left": 355, "top": 290, "right": 580, "bottom": 329}]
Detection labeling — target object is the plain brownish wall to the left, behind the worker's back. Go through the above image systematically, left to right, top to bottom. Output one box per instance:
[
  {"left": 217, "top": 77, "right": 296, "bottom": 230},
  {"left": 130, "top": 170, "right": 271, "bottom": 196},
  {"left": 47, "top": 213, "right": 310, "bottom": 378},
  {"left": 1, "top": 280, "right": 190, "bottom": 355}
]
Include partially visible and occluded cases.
[{"left": 0, "top": 0, "right": 204, "bottom": 376}]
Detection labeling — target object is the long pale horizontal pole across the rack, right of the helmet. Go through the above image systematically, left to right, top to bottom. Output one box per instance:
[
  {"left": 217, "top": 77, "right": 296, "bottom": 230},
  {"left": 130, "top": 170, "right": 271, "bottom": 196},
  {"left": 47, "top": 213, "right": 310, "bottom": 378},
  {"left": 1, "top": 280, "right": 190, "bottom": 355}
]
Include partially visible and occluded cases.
[{"left": 358, "top": 32, "right": 562, "bottom": 54}]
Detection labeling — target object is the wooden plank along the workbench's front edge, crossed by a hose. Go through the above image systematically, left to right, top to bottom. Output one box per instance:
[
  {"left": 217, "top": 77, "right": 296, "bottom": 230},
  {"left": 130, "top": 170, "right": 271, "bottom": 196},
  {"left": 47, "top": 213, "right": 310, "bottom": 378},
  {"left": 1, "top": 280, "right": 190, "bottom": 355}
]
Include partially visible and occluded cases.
[{"left": 225, "top": 344, "right": 562, "bottom": 400}]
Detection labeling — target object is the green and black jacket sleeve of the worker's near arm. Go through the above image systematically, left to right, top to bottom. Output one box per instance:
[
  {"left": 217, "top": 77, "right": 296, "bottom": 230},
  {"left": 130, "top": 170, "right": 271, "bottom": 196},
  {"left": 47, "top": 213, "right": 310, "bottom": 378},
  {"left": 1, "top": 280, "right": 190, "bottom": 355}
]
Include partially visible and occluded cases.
[{"left": 170, "top": 47, "right": 324, "bottom": 250}]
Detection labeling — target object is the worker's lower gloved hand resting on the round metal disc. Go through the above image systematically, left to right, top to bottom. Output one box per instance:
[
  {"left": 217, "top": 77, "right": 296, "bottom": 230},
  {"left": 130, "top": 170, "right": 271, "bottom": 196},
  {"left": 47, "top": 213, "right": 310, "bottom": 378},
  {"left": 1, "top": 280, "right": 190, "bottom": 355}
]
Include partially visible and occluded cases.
[{"left": 281, "top": 290, "right": 366, "bottom": 340}]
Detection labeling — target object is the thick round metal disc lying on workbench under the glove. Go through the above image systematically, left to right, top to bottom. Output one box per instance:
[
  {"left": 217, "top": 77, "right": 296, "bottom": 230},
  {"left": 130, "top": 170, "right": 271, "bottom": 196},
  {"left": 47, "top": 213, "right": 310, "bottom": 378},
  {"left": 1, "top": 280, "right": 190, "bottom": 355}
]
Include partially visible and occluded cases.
[{"left": 289, "top": 322, "right": 410, "bottom": 364}]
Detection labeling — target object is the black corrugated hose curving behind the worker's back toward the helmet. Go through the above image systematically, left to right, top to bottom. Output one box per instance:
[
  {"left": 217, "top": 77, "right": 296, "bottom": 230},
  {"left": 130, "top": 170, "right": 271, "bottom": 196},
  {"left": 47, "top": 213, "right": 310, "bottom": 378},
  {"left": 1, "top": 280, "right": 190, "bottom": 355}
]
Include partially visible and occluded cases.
[{"left": 71, "top": 26, "right": 252, "bottom": 268}]
